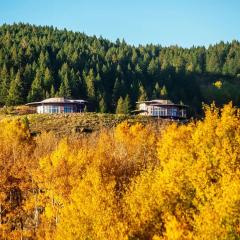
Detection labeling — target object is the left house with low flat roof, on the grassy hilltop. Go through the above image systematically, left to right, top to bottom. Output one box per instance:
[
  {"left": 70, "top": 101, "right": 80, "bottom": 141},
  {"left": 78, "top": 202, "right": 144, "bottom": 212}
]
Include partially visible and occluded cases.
[{"left": 26, "top": 97, "right": 87, "bottom": 113}]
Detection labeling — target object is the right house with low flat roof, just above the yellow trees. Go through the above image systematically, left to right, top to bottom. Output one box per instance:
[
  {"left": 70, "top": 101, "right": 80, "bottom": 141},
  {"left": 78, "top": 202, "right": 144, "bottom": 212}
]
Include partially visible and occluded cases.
[{"left": 135, "top": 99, "right": 188, "bottom": 120}]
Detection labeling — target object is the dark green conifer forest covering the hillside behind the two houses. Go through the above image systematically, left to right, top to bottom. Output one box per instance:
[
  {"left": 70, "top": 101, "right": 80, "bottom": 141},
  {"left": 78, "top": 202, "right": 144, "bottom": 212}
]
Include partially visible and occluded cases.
[{"left": 0, "top": 24, "right": 240, "bottom": 112}]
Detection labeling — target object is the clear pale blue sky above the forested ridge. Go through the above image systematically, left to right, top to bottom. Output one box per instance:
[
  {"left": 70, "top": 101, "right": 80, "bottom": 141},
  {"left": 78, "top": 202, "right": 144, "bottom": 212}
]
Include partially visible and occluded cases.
[{"left": 0, "top": 0, "right": 240, "bottom": 47}]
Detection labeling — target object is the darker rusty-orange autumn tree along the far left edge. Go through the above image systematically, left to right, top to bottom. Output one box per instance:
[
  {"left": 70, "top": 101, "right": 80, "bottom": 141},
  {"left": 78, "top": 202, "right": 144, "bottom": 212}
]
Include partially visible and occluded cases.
[{"left": 0, "top": 119, "right": 33, "bottom": 239}]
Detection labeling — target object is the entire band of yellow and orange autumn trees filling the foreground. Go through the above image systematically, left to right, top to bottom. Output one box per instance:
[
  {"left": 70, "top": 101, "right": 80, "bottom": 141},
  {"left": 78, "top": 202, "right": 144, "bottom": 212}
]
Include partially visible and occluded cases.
[{"left": 0, "top": 104, "right": 240, "bottom": 240}]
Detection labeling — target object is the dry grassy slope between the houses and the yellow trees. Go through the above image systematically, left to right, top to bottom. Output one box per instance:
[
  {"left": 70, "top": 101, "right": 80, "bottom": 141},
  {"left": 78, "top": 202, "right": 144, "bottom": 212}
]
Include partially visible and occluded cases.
[{"left": 0, "top": 107, "right": 167, "bottom": 136}]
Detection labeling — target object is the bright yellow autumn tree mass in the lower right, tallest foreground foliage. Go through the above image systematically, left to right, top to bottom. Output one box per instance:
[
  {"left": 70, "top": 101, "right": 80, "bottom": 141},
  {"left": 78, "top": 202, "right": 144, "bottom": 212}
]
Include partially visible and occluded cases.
[{"left": 124, "top": 104, "right": 240, "bottom": 240}]
